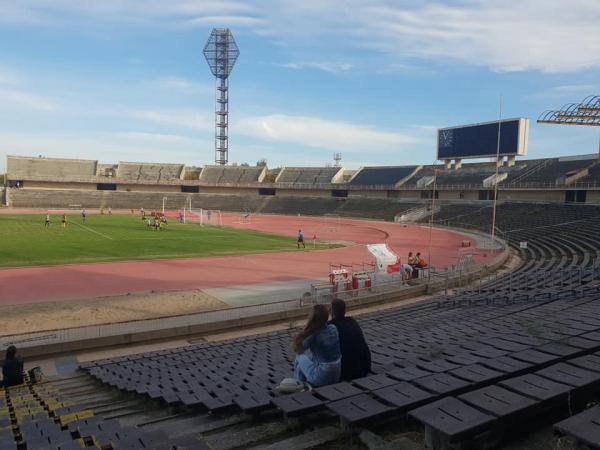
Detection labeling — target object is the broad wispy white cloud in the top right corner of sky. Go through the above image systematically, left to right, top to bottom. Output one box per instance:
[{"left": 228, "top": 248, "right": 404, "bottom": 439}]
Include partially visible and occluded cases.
[{"left": 363, "top": 0, "right": 600, "bottom": 72}]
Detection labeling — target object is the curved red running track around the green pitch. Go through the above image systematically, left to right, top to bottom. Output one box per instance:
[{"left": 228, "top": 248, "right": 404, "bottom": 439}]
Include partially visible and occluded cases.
[{"left": 0, "top": 214, "right": 492, "bottom": 305}]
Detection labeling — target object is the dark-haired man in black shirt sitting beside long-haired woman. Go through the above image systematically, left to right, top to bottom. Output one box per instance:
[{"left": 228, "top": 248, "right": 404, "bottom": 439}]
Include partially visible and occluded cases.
[{"left": 329, "top": 299, "right": 371, "bottom": 381}]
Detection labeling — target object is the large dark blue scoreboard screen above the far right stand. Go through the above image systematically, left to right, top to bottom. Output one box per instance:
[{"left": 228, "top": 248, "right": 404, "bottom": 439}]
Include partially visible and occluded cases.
[{"left": 437, "top": 118, "right": 529, "bottom": 160}]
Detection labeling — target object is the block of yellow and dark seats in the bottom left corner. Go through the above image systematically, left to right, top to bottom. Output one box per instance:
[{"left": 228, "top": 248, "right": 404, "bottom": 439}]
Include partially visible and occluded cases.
[{"left": 0, "top": 380, "right": 206, "bottom": 450}]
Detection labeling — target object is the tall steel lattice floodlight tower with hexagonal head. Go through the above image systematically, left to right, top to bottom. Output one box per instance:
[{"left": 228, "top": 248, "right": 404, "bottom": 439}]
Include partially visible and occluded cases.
[{"left": 203, "top": 28, "right": 240, "bottom": 165}]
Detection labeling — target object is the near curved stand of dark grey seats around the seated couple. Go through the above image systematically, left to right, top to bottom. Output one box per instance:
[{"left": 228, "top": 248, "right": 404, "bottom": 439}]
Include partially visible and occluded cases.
[{"left": 22, "top": 203, "right": 600, "bottom": 449}]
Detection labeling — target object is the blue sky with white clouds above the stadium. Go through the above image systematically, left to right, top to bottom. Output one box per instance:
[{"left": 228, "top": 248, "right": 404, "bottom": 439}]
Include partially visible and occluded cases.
[{"left": 0, "top": 0, "right": 600, "bottom": 170}]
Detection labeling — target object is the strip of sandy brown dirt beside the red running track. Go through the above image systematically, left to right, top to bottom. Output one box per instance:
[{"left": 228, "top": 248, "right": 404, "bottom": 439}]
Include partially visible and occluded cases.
[{"left": 0, "top": 290, "right": 228, "bottom": 336}]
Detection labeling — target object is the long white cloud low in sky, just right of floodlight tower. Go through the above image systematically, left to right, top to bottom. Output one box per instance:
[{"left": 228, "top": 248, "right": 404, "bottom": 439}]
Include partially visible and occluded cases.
[{"left": 234, "top": 114, "right": 417, "bottom": 153}]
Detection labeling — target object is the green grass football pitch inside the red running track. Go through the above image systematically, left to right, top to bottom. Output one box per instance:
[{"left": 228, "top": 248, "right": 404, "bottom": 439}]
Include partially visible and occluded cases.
[{"left": 0, "top": 214, "right": 329, "bottom": 267}]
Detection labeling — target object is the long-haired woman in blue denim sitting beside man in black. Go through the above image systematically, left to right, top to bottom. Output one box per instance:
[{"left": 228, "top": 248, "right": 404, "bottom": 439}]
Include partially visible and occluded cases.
[{"left": 293, "top": 305, "right": 342, "bottom": 387}]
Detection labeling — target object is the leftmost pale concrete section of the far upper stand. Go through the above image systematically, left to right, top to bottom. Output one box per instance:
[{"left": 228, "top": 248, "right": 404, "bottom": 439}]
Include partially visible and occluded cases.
[{"left": 6, "top": 156, "right": 98, "bottom": 180}]
